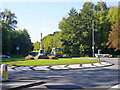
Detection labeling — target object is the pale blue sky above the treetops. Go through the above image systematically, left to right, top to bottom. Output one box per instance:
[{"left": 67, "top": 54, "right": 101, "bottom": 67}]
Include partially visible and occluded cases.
[{"left": 0, "top": 0, "right": 118, "bottom": 43}]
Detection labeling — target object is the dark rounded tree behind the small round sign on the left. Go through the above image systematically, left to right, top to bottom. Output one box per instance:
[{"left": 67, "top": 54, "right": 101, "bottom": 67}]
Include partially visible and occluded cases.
[{"left": 10, "top": 29, "right": 32, "bottom": 55}]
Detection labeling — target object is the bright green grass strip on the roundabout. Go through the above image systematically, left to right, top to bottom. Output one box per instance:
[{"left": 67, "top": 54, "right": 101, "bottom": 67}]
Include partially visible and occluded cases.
[{"left": 2, "top": 58, "right": 103, "bottom": 66}]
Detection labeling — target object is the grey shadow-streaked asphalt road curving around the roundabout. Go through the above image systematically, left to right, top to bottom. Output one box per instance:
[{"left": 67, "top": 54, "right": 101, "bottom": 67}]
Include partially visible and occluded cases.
[{"left": 9, "top": 58, "right": 120, "bottom": 89}]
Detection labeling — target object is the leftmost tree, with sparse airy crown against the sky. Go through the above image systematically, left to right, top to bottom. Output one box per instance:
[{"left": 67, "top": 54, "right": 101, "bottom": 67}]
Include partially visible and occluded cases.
[{"left": 0, "top": 9, "right": 17, "bottom": 54}]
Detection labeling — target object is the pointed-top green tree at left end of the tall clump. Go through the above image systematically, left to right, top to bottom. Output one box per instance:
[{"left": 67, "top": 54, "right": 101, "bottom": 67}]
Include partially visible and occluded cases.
[{"left": 59, "top": 8, "right": 80, "bottom": 56}]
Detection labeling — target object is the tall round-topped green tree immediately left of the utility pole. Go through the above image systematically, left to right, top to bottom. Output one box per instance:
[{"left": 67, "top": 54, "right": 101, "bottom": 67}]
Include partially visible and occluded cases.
[{"left": 80, "top": 2, "right": 95, "bottom": 56}]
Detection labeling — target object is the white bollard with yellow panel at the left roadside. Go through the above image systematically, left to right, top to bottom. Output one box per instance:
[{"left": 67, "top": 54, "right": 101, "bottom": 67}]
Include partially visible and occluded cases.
[{"left": 1, "top": 64, "right": 8, "bottom": 81}]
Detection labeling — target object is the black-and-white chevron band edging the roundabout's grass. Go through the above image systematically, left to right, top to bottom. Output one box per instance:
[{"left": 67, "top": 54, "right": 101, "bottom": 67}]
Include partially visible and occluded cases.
[{"left": 8, "top": 61, "right": 114, "bottom": 71}]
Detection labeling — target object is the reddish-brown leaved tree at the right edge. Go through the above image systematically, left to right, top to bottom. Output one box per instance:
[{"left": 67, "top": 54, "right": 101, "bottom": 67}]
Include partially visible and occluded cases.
[{"left": 106, "top": 19, "right": 120, "bottom": 51}]
